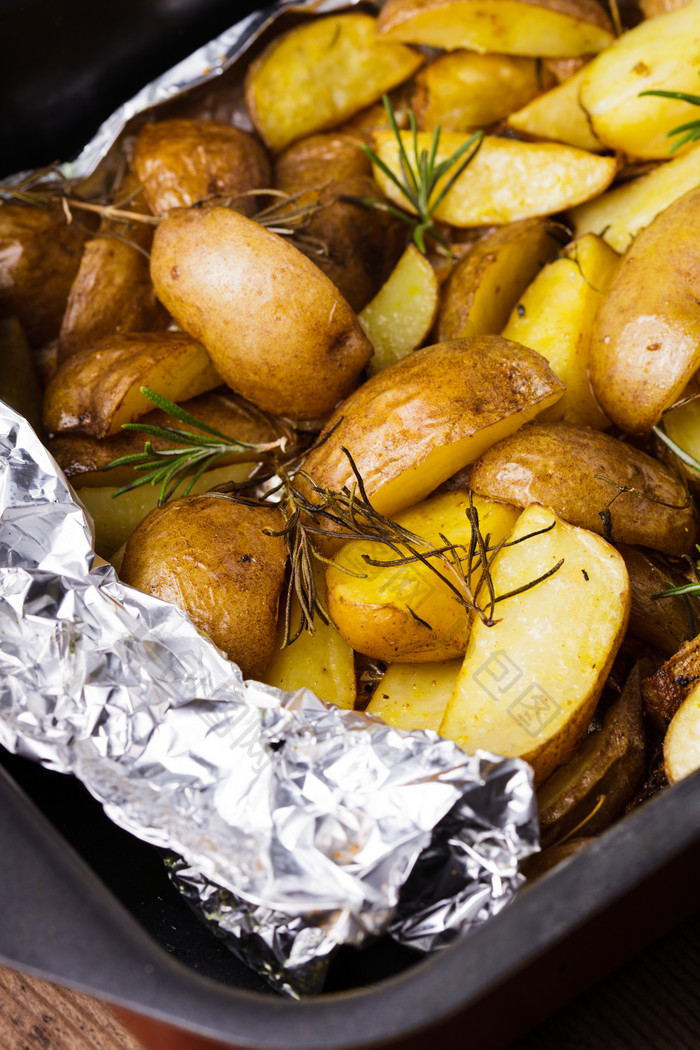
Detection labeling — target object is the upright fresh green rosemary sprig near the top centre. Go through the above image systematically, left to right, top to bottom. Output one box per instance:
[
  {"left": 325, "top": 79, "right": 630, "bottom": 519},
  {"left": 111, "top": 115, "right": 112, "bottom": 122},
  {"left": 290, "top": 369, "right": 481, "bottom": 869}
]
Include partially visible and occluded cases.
[{"left": 345, "top": 95, "right": 484, "bottom": 255}]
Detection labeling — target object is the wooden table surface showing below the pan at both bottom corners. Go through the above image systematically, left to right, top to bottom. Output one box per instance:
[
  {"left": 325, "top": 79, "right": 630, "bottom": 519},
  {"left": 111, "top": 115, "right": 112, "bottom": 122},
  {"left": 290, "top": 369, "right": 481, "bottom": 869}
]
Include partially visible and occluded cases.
[{"left": 0, "top": 911, "right": 700, "bottom": 1050}]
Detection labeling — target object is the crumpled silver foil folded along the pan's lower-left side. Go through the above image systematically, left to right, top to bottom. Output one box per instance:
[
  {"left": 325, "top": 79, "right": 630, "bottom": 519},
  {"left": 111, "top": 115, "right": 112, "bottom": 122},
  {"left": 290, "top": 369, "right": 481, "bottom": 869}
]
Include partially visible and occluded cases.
[{"left": 0, "top": 403, "right": 537, "bottom": 995}]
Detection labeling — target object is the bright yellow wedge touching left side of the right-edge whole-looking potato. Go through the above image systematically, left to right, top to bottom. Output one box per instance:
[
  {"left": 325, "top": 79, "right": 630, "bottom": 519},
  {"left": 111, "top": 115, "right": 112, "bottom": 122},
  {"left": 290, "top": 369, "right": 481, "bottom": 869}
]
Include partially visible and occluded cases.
[{"left": 503, "top": 233, "right": 619, "bottom": 429}]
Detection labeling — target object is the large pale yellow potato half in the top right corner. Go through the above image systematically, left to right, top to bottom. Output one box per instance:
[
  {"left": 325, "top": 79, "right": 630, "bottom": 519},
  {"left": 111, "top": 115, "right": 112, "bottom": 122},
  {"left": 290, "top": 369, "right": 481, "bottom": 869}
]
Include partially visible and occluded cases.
[{"left": 580, "top": 0, "right": 700, "bottom": 160}]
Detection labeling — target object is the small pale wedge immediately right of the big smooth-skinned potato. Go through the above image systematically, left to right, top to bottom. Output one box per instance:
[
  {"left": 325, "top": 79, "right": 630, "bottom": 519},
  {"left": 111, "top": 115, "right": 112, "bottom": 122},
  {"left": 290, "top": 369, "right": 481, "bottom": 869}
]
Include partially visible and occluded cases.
[{"left": 358, "top": 245, "right": 440, "bottom": 374}]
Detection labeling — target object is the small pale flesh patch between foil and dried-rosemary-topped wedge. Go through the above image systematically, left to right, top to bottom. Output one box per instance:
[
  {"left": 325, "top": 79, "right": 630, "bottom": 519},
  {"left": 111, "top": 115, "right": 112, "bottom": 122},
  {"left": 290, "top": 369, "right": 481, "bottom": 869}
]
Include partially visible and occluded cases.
[{"left": 367, "top": 659, "right": 462, "bottom": 733}]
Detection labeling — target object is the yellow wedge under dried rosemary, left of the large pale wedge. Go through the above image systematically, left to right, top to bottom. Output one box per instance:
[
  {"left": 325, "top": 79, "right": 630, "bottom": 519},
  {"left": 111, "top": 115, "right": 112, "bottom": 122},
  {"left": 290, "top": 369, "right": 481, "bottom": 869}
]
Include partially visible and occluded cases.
[{"left": 325, "top": 492, "right": 519, "bottom": 663}]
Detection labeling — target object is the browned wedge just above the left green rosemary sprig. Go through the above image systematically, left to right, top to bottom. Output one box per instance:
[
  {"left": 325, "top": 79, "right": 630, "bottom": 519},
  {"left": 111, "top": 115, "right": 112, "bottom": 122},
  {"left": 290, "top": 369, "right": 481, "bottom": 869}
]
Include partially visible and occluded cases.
[{"left": 44, "top": 332, "right": 221, "bottom": 438}]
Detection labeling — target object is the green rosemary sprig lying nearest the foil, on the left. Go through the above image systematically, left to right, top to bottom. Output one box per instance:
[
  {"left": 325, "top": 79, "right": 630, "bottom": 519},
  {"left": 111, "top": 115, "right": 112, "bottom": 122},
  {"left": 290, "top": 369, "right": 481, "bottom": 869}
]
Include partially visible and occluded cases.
[{"left": 104, "top": 386, "right": 287, "bottom": 506}]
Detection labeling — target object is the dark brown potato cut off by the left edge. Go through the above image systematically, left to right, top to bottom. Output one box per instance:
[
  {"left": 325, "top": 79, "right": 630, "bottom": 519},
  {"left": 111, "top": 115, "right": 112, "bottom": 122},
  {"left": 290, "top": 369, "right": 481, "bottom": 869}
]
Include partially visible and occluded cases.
[{"left": 0, "top": 202, "right": 89, "bottom": 348}]
